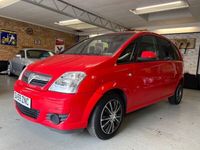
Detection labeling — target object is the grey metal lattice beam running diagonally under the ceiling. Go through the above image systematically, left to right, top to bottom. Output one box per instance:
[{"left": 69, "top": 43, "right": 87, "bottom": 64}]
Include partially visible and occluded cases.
[{"left": 22, "top": 0, "right": 128, "bottom": 32}]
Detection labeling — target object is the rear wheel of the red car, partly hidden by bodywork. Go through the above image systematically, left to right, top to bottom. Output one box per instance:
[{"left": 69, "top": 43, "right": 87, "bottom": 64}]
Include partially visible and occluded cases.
[{"left": 169, "top": 82, "right": 183, "bottom": 105}]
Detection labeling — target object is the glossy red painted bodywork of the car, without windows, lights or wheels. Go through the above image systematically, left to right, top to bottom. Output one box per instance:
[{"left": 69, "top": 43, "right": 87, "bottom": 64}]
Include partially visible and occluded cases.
[{"left": 14, "top": 32, "right": 183, "bottom": 130}]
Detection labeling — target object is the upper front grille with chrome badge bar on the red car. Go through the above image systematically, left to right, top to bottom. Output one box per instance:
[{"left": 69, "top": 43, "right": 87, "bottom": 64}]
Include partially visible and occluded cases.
[{"left": 22, "top": 71, "right": 51, "bottom": 87}]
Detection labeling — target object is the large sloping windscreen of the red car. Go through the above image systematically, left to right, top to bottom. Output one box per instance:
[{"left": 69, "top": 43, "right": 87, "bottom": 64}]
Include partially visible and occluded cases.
[{"left": 64, "top": 33, "right": 133, "bottom": 56}]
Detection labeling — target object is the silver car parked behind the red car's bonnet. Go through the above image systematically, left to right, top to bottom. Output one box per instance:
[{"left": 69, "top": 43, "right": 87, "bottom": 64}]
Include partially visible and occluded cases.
[{"left": 8, "top": 48, "right": 54, "bottom": 76}]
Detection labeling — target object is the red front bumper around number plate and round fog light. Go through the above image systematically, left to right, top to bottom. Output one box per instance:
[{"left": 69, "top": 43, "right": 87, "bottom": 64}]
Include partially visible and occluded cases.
[{"left": 14, "top": 80, "right": 92, "bottom": 130}]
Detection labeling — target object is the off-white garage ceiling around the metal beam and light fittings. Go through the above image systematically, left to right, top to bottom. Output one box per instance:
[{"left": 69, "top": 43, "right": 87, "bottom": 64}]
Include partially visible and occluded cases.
[{"left": 0, "top": 0, "right": 200, "bottom": 34}]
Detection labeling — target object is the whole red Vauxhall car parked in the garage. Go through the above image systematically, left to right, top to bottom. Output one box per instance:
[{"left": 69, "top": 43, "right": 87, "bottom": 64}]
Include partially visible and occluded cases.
[{"left": 14, "top": 32, "right": 183, "bottom": 139}]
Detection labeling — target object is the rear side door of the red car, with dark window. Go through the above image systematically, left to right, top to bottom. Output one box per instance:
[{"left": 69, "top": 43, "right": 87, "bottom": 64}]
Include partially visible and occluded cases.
[{"left": 157, "top": 38, "right": 181, "bottom": 96}]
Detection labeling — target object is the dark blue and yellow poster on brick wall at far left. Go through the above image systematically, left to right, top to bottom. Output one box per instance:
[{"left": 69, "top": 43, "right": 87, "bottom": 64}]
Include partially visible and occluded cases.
[{"left": 0, "top": 30, "right": 17, "bottom": 46}]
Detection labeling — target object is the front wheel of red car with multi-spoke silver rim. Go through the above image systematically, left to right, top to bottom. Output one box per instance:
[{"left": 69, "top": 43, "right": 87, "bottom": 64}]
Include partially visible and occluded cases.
[{"left": 87, "top": 93, "right": 125, "bottom": 140}]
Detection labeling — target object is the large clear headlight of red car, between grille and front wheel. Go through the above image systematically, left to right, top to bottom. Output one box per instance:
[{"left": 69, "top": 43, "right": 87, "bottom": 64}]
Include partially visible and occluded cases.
[{"left": 49, "top": 71, "right": 86, "bottom": 93}]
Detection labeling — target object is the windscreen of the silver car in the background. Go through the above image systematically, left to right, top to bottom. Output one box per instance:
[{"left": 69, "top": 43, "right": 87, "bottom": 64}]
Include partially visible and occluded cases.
[{"left": 27, "top": 50, "right": 53, "bottom": 59}]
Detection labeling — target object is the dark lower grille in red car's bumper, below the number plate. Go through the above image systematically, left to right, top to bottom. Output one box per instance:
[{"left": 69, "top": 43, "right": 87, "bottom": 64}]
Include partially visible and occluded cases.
[{"left": 16, "top": 102, "right": 39, "bottom": 119}]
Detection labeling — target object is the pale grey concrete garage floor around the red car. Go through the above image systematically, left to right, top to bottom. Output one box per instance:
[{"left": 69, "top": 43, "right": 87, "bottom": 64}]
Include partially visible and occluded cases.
[{"left": 0, "top": 75, "right": 200, "bottom": 150}]
